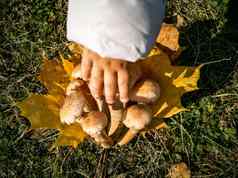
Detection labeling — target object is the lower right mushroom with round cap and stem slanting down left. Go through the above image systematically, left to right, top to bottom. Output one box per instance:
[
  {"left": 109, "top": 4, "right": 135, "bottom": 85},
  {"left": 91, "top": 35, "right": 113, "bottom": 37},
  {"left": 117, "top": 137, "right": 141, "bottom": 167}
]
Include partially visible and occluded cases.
[{"left": 118, "top": 104, "right": 152, "bottom": 145}]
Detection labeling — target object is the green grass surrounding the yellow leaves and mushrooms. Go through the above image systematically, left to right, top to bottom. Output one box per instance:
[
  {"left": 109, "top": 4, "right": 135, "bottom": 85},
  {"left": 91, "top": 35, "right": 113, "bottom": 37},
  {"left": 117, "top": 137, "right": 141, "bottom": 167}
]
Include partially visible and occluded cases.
[{"left": 0, "top": 0, "right": 238, "bottom": 178}]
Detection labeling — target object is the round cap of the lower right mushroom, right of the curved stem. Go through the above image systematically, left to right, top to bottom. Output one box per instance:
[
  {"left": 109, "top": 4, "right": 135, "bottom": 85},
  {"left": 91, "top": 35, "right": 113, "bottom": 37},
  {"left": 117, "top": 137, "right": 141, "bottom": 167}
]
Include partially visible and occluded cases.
[{"left": 123, "top": 104, "right": 152, "bottom": 131}]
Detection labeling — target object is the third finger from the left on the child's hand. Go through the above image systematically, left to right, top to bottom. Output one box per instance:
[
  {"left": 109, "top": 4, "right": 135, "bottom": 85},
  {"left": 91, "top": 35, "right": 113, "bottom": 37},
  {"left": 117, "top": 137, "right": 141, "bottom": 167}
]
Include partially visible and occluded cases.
[{"left": 104, "top": 69, "right": 117, "bottom": 104}]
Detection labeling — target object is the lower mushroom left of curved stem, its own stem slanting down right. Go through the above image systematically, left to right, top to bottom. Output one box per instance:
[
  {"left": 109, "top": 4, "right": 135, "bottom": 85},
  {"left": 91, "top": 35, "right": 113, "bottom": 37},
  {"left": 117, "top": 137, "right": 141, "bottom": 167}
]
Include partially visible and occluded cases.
[{"left": 79, "top": 111, "right": 113, "bottom": 148}]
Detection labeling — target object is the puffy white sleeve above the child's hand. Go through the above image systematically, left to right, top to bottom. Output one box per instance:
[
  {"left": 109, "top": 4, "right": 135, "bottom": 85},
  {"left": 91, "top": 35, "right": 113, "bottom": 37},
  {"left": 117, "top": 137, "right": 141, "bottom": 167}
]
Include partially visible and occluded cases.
[{"left": 67, "top": 0, "right": 165, "bottom": 62}]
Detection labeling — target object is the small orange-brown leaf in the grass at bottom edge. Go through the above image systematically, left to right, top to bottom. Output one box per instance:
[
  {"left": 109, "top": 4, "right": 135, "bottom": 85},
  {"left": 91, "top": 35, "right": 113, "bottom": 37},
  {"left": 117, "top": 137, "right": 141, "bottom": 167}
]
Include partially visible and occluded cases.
[{"left": 168, "top": 162, "right": 191, "bottom": 178}]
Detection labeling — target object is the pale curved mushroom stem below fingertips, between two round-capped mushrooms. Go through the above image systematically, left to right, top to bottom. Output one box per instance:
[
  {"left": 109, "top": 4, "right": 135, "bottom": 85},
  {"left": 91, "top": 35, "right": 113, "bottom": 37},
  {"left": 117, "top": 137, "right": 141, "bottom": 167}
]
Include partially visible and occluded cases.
[{"left": 108, "top": 101, "right": 123, "bottom": 136}]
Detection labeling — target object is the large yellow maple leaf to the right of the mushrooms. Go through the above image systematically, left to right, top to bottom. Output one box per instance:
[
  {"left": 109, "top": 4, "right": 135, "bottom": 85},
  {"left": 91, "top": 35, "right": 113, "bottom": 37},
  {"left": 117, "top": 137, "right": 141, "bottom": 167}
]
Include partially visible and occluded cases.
[{"left": 140, "top": 49, "right": 201, "bottom": 128}]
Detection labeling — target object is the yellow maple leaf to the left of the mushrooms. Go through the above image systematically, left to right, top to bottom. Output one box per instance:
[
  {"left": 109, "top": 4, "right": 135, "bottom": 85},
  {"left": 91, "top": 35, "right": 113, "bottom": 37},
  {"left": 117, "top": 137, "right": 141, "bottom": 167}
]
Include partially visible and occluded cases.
[{"left": 17, "top": 56, "right": 86, "bottom": 147}]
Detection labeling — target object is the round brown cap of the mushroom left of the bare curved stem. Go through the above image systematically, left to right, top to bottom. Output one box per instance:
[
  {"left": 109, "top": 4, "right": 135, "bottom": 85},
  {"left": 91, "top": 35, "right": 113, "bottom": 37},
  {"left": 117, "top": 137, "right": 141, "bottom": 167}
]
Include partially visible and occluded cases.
[{"left": 79, "top": 111, "right": 107, "bottom": 136}]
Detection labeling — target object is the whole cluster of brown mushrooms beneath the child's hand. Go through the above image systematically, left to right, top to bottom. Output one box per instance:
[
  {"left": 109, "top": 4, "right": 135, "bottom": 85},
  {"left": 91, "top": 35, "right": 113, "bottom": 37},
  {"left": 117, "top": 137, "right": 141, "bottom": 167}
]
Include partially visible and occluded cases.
[{"left": 60, "top": 63, "right": 160, "bottom": 148}]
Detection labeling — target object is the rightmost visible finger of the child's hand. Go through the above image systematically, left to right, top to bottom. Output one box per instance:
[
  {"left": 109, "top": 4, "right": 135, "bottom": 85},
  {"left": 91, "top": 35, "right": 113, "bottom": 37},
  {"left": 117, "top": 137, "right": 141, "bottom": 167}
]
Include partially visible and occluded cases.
[{"left": 117, "top": 69, "right": 129, "bottom": 103}]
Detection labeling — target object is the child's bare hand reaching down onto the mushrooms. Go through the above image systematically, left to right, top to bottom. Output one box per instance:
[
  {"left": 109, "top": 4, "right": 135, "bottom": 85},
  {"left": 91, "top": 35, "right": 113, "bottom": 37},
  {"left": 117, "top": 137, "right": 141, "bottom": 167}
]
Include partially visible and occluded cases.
[{"left": 80, "top": 49, "right": 129, "bottom": 104}]
